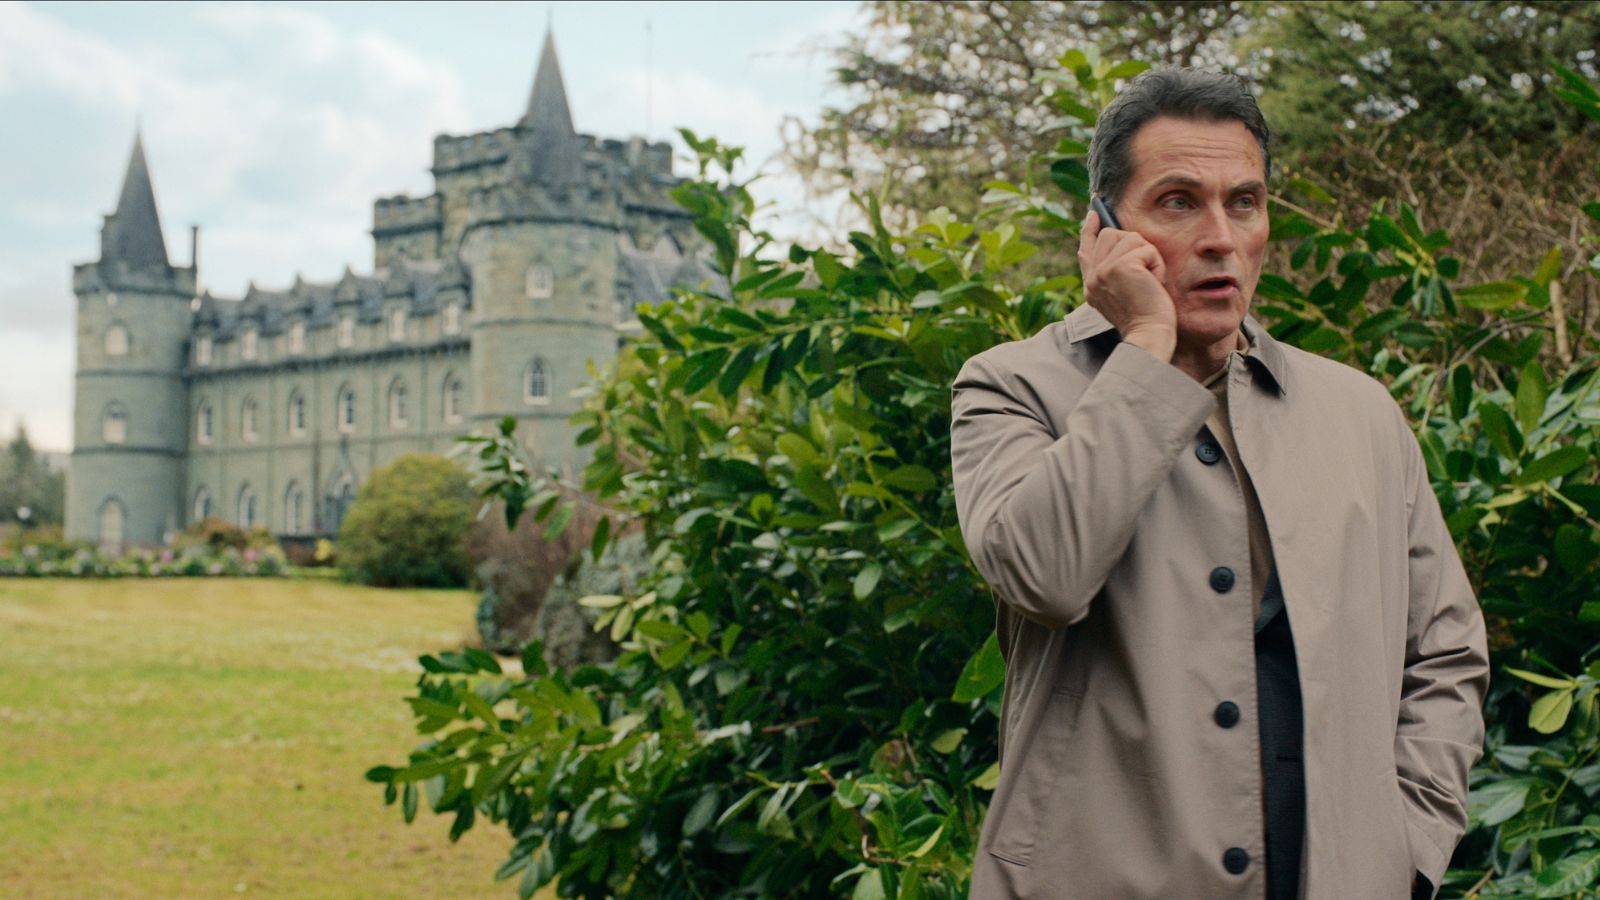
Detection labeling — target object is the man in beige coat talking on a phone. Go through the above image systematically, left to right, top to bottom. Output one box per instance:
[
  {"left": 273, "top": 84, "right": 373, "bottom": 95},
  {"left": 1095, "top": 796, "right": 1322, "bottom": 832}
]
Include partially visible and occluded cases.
[{"left": 952, "top": 69, "right": 1488, "bottom": 900}]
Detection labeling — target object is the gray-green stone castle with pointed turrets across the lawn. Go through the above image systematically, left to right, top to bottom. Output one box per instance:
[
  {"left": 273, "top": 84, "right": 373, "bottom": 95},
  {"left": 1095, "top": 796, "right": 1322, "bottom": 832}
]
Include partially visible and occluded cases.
[{"left": 66, "top": 34, "right": 712, "bottom": 546}]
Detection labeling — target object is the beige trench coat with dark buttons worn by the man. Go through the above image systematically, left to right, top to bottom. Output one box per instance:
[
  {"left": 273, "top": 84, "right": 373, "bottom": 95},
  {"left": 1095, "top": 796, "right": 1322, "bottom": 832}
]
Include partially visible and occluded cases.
[{"left": 952, "top": 306, "right": 1488, "bottom": 900}]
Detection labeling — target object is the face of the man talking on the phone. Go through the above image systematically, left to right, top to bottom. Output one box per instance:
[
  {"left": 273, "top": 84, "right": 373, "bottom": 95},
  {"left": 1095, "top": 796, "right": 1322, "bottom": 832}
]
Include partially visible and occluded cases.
[{"left": 1115, "top": 115, "right": 1267, "bottom": 346}]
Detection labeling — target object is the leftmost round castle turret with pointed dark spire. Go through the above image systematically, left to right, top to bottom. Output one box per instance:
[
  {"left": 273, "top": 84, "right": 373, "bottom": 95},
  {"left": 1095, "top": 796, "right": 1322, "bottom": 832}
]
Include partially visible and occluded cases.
[{"left": 66, "top": 128, "right": 195, "bottom": 546}]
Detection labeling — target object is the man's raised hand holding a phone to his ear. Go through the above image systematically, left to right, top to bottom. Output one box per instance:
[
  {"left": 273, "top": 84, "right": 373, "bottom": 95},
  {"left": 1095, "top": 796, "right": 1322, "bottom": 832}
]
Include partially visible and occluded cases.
[{"left": 1078, "top": 197, "right": 1178, "bottom": 362}]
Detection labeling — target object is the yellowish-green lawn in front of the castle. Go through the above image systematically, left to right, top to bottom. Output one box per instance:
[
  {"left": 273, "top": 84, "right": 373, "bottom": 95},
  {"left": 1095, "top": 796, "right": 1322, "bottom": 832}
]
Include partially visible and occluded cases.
[{"left": 0, "top": 578, "right": 515, "bottom": 900}]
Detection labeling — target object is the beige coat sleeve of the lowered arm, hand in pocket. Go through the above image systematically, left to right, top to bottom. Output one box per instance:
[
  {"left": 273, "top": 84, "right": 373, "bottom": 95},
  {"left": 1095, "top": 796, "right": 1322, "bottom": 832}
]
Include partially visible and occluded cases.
[{"left": 1395, "top": 410, "right": 1490, "bottom": 886}]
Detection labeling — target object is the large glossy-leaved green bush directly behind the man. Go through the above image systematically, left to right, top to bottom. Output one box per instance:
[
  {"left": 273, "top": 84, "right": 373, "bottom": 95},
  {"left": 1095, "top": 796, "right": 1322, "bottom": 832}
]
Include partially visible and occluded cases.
[{"left": 368, "top": 54, "right": 1600, "bottom": 897}]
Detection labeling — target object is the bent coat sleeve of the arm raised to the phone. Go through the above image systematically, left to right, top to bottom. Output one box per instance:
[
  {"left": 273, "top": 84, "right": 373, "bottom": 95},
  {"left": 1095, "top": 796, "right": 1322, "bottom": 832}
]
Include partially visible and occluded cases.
[{"left": 950, "top": 344, "right": 1216, "bottom": 628}]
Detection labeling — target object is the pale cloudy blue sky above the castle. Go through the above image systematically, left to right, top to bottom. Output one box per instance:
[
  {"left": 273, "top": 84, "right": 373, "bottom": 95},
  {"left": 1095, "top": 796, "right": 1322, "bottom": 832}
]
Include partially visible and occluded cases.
[{"left": 0, "top": 0, "right": 862, "bottom": 450}]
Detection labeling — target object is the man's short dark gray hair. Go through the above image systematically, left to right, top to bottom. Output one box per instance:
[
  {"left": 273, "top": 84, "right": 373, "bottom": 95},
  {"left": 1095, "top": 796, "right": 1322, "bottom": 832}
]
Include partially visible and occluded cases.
[{"left": 1090, "top": 67, "right": 1272, "bottom": 207}]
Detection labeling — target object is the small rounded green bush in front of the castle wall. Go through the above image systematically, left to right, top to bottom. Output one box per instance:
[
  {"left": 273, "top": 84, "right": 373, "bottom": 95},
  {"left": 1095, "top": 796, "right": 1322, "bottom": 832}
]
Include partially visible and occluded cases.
[{"left": 338, "top": 453, "right": 474, "bottom": 588}]
